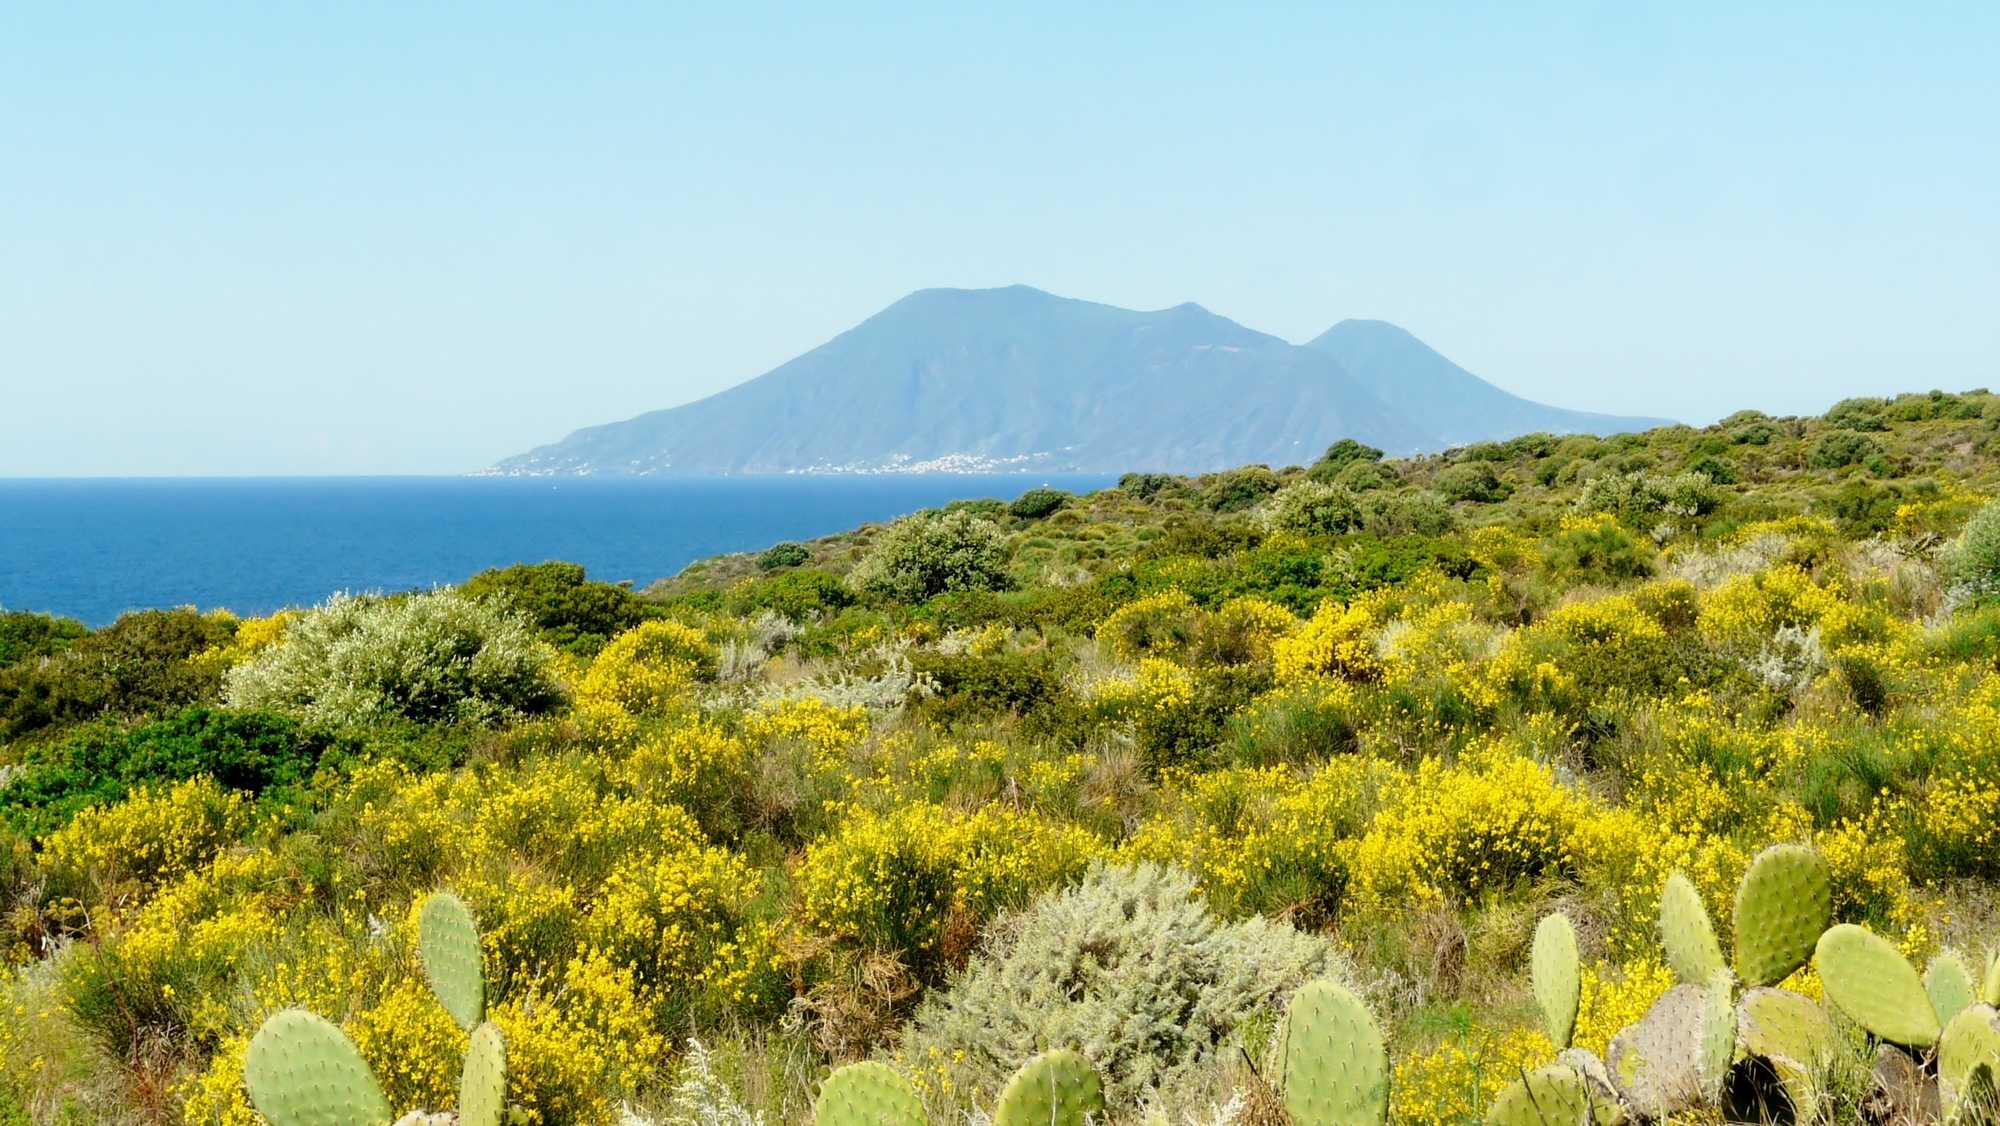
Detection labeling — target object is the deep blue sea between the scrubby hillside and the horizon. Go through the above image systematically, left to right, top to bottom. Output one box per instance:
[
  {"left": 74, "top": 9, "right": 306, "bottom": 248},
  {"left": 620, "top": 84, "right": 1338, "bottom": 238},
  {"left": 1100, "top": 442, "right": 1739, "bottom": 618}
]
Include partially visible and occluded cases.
[{"left": 0, "top": 474, "right": 1114, "bottom": 626}]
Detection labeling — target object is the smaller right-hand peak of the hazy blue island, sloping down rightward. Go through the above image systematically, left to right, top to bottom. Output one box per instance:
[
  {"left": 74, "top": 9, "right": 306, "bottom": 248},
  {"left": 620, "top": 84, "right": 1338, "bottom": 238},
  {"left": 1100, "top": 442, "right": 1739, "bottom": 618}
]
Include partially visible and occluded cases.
[{"left": 1306, "top": 320, "right": 1670, "bottom": 446}]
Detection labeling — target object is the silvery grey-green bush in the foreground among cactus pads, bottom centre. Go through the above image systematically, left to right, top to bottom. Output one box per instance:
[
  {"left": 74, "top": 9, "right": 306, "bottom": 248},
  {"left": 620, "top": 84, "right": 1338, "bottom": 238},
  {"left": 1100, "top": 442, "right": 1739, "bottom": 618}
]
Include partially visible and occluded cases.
[{"left": 904, "top": 864, "right": 1346, "bottom": 1106}]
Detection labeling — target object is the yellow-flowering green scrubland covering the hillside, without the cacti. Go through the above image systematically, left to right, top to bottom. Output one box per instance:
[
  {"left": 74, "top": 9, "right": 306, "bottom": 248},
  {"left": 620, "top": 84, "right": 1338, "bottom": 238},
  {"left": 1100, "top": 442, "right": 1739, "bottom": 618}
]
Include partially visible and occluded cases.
[{"left": 0, "top": 392, "right": 2000, "bottom": 1126}]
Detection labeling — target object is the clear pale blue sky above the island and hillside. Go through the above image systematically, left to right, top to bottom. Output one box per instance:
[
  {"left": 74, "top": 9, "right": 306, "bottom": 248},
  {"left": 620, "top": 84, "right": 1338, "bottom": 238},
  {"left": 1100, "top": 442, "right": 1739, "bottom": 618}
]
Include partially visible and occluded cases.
[{"left": 0, "top": 0, "right": 2000, "bottom": 476}]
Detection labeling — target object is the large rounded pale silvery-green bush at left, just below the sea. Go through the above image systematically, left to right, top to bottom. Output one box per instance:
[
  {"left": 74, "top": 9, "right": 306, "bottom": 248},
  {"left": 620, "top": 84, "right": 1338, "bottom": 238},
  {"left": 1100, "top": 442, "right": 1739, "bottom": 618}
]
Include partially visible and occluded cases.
[{"left": 226, "top": 588, "right": 558, "bottom": 724}]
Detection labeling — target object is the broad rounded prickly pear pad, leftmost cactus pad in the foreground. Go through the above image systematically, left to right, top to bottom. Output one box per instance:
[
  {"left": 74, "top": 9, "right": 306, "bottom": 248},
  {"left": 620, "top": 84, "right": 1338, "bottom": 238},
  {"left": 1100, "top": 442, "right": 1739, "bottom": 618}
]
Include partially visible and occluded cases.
[{"left": 244, "top": 1008, "right": 392, "bottom": 1126}]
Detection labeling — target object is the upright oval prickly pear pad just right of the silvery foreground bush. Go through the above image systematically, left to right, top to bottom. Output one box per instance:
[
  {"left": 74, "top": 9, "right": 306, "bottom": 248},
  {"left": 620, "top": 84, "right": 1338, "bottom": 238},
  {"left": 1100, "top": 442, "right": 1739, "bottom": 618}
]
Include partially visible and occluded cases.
[{"left": 1280, "top": 980, "right": 1388, "bottom": 1126}]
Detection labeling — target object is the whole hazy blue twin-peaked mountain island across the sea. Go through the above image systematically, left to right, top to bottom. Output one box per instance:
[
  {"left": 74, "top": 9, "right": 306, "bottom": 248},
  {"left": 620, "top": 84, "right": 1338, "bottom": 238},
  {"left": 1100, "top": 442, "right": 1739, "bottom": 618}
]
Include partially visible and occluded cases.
[{"left": 490, "top": 286, "right": 1660, "bottom": 474}]
